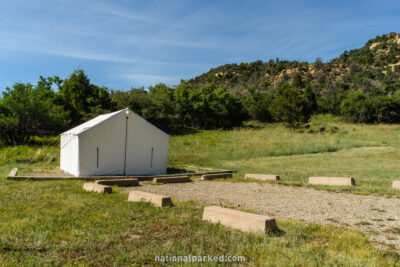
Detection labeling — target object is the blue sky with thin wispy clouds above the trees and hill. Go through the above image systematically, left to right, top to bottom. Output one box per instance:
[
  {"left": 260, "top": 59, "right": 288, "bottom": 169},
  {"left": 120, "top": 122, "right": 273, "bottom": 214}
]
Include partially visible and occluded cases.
[{"left": 0, "top": 0, "right": 400, "bottom": 91}]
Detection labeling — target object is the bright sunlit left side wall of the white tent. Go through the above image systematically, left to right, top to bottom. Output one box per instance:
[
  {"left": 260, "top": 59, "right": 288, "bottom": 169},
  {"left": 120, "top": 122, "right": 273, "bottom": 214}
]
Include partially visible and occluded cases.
[{"left": 60, "top": 134, "right": 79, "bottom": 176}]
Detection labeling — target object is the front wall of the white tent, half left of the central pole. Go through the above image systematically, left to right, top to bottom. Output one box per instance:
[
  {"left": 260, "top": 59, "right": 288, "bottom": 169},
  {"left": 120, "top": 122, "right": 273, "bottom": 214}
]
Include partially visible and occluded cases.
[{"left": 79, "top": 112, "right": 126, "bottom": 176}]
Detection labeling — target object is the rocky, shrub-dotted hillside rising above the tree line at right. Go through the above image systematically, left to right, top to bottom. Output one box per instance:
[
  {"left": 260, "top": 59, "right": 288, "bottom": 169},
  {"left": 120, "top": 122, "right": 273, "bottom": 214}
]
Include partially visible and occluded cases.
[{"left": 190, "top": 33, "right": 400, "bottom": 101}]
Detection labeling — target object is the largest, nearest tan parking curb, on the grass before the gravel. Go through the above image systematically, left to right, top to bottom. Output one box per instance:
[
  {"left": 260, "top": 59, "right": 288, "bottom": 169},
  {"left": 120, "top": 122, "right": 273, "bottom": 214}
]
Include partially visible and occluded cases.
[{"left": 203, "top": 206, "right": 278, "bottom": 232}]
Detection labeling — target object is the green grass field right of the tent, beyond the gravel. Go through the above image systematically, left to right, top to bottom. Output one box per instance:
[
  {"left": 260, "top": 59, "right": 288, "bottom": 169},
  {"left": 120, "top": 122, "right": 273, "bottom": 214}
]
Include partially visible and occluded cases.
[{"left": 169, "top": 116, "right": 400, "bottom": 196}]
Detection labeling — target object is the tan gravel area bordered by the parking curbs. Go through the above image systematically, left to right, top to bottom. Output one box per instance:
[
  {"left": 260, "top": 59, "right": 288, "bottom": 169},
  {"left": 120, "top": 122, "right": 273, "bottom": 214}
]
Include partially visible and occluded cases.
[{"left": 126, "top": 181, "right": 400, "bottom": 252}]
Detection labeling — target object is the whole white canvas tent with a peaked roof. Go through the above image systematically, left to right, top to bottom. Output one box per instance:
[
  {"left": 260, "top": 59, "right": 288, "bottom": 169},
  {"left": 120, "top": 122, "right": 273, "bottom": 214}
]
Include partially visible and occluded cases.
[{"left": 60, "top": 108, "right": 169, "bottom": 176}]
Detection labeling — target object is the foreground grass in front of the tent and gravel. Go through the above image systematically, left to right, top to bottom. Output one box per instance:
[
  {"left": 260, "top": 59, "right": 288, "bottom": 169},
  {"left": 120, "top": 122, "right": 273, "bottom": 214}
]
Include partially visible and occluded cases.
[{"left": 0, "top": 178, "right": 400, "bottom": 266}]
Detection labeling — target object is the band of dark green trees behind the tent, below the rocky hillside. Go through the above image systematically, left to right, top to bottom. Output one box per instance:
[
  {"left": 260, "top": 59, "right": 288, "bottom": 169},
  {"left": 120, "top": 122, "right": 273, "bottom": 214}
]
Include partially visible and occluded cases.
[{"left": 0, "top": 66, "right": 400, "bottom": 147}]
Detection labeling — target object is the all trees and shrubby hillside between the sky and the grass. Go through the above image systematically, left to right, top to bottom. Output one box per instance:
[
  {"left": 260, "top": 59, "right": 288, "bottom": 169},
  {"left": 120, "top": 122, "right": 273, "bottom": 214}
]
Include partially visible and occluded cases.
[{"left": 0, "top": 33, "right": 400, "bottom": 144}]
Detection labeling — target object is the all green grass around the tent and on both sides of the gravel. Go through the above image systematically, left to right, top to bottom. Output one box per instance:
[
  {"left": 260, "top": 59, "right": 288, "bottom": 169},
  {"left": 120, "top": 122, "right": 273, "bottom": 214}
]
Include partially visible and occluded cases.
[{"left": 0, "top": 116, "right": 400, "bottom": 266}]
